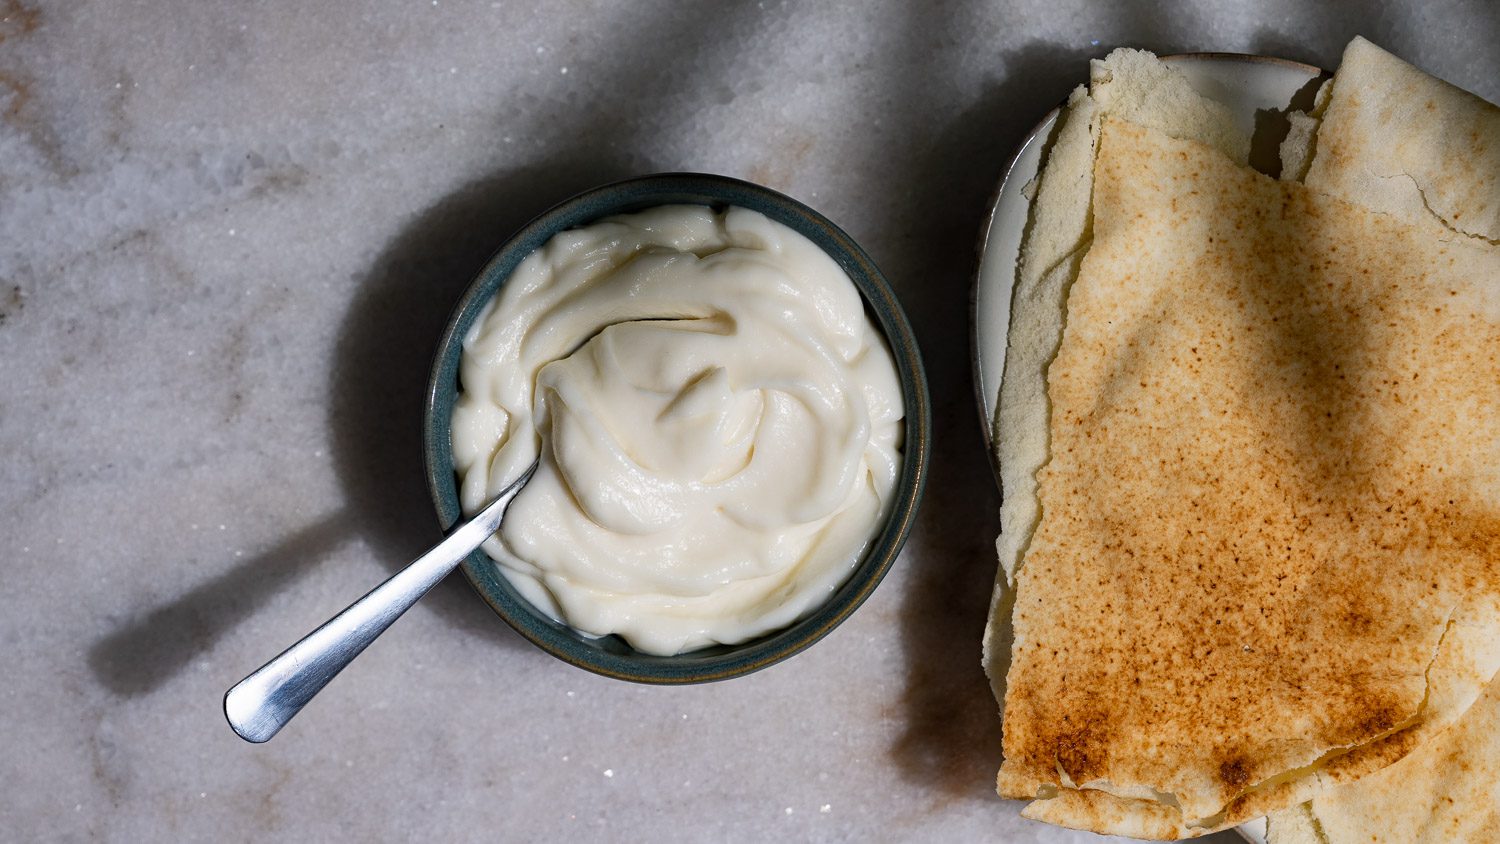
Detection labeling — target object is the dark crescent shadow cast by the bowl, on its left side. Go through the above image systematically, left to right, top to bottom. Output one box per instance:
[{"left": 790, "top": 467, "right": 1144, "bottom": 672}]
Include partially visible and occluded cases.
[{"left": 329, "top": 150, "right": 630, "bottom": 648}]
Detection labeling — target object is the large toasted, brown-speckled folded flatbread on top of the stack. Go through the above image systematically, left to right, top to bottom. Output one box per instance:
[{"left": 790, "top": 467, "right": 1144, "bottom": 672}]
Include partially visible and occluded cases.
[{"left": 999, "top": 121, "right": 1500, "bottom": 838}]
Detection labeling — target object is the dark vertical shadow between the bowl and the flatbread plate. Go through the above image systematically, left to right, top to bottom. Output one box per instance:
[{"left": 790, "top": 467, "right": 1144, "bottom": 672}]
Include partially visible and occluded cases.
[{"left": 890, "top": 43, "right": 1098, "bottom": 802}]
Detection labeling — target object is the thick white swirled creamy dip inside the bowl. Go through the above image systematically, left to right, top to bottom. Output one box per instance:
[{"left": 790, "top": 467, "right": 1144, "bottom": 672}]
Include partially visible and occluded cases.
[{"left": 453, "top": 205, "right": 903, "bottom": 655}]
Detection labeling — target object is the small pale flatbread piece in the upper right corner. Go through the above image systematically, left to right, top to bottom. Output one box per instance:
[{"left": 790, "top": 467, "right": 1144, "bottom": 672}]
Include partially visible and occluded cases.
[{"left": 1304, "top": 37, "right": 1500, "bottom": 241}]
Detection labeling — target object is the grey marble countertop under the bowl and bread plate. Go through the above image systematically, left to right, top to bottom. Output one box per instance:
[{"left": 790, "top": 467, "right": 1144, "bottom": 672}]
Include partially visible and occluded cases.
[{"left": 0, "top": 0, "right": 1500, "bottom": 841}]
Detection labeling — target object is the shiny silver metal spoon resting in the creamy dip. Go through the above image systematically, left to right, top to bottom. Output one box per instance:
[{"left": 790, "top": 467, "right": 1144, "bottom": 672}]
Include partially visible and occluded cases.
[{"left": 224, "top": 462, "right": 537, "bottom": 744}]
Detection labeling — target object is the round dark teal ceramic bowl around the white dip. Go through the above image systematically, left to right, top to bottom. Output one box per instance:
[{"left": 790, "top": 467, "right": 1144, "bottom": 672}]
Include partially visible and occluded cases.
[{"left": 423, "top": 174, "right": 932, "bottom": 684}]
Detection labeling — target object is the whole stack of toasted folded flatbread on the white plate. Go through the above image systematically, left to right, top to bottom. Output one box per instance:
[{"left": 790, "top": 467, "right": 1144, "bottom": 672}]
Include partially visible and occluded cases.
[{"left": 986, "top": 40, "right": 1500, "bottom": 841}]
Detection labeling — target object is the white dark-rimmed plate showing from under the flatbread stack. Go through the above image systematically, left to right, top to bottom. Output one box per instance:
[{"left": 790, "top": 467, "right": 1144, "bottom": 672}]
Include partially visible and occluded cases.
[{"left": 972, "top": 52, "right": 1325, "bottom": 844}]
